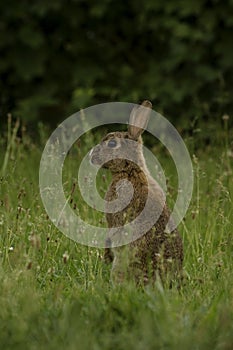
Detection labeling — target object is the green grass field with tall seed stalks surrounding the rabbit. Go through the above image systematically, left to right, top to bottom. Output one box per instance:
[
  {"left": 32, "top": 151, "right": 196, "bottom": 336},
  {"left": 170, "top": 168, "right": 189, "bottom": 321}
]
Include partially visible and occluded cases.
[{"left": 0, "top": 120, "right": 233, "bottom": 350}]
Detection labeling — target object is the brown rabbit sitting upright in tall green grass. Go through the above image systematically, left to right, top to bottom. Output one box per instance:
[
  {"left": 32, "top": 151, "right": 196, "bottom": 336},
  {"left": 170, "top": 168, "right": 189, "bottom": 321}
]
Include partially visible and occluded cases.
[{"left": 90, "top": 100, "right": 183, "bottom": 285}]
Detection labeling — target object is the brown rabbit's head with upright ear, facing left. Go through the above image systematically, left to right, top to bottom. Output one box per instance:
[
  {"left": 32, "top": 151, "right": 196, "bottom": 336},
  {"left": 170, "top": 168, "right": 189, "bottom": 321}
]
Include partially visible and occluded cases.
[{"left": 90, "top": 101, "right": 152, "bottom": 173}]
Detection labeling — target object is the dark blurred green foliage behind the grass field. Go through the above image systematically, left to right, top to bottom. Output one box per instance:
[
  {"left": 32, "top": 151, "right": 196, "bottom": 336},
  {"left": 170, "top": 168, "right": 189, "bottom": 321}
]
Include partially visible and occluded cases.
[{"left": 0, "top": 0, "right": 233, "bottom": 127}]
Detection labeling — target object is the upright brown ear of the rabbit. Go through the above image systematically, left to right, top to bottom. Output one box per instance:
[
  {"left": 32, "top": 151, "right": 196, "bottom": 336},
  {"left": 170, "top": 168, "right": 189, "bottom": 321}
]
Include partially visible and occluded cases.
[{"left": 128, "top": 100, "right": 152, "bottom": 140}]
